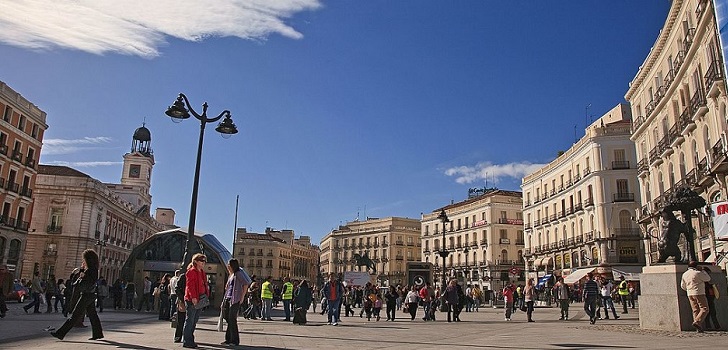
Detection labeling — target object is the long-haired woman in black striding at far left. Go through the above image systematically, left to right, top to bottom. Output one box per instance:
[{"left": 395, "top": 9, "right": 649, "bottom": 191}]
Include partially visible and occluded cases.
[{"left": 51, "top": 249, "right": 104, "bottom": 340}]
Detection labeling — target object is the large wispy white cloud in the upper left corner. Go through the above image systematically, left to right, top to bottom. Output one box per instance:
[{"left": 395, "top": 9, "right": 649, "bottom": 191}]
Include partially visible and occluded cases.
[{"left": 0, "top": 0, "right": 321, "bottom": 57}]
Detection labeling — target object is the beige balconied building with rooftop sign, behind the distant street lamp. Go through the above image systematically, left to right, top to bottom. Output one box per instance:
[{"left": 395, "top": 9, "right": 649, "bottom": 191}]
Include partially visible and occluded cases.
[{"left": 422, "top": 189, "right": 524, "bottom": 290}]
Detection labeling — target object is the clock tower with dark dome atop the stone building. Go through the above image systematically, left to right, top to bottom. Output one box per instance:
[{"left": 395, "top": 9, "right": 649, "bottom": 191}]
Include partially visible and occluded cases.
[{"left": 121, "top": 124, "right": 154, "bottom": 207}]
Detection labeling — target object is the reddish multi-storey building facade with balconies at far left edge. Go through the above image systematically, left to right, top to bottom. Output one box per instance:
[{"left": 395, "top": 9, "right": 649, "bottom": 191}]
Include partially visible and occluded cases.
[{"left": 0, "top": 81, "right": 48, "bottom": 276}]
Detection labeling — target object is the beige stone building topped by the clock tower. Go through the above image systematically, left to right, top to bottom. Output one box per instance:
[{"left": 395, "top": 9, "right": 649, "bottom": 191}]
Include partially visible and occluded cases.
[{"left": 22, "top": 126, "right": 168, "bottom": 281}]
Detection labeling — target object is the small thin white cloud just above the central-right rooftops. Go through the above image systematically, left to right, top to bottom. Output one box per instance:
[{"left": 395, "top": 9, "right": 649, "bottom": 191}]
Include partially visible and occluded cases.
[{"left": 445, "top": 162, "right": 546, "bottom": 184}]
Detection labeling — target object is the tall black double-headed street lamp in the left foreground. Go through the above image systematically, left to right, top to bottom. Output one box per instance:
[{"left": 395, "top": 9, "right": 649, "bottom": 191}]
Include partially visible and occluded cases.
[{"left": 165, "top": 93, "right": 238, "bottom": 267}]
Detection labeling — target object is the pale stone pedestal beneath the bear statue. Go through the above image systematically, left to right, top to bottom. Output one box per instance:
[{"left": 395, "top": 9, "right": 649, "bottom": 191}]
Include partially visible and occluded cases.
[{"left": 638, "top": 265, "right": 728, "bottom": 331}]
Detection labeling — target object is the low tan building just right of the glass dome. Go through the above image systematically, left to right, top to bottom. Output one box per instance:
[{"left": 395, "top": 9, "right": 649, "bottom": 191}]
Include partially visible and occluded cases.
[{"left": 233, "top": 227, "right": 319, "bottom": 282}]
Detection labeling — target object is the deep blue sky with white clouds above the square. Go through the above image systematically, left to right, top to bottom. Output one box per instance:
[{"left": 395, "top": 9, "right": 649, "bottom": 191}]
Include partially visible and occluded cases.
[{"left": 0, "top": 0, "right": 670, "bottom": 248}]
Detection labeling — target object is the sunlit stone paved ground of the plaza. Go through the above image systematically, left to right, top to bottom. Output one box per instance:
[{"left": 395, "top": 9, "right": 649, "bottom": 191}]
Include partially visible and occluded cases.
[{"left": 0, "top": 304, "right": 728, "bottom": 350}]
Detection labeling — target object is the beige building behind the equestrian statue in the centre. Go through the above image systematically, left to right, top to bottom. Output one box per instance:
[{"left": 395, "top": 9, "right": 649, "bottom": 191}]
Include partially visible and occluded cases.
[{"left": 321, "top": 217, "right": 421, "bottom": 285}]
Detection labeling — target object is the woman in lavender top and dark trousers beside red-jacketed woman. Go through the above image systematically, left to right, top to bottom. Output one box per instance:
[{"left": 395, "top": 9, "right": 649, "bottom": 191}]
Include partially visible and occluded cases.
[{"left": 221, "top": 259, "right": 252, "bottom": 346}]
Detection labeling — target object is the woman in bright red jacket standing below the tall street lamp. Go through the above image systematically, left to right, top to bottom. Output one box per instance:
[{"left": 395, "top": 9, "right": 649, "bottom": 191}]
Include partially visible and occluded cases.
[{"left": 183, "top": 253, "right": 210, "bottom": 349}]
